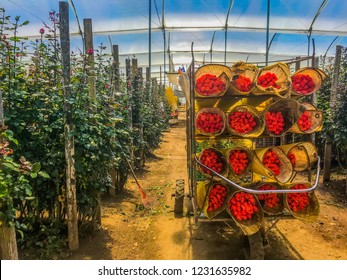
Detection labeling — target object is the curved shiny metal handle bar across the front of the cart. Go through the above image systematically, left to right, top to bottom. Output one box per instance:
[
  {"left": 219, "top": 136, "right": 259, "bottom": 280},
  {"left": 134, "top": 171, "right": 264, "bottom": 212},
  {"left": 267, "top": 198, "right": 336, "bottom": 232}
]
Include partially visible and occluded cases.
[{"left": 194, "top": 155, "right": 320, "bottom": 194}]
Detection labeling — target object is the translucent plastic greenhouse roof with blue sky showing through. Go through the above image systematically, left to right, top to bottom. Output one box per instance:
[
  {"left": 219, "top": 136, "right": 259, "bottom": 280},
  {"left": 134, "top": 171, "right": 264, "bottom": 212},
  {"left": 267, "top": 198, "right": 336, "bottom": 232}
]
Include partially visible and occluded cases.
[{"left": 0, "top": 0, "right": 347, "bottom": 75}]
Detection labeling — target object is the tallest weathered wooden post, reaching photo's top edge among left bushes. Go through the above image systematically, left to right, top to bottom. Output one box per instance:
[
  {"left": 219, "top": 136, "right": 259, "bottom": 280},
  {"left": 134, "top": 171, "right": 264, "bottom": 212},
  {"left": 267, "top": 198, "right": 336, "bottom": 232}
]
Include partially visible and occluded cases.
[{"left": 59, "top": 2, "right": 79, "bottom": 251}]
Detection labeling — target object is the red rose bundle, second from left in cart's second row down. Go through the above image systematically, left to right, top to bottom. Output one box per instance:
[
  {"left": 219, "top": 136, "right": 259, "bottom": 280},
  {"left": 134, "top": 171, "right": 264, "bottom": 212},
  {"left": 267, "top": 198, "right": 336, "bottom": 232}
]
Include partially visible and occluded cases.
[{"left": 227, "top": 105, "right": 264, "bottom": 137}]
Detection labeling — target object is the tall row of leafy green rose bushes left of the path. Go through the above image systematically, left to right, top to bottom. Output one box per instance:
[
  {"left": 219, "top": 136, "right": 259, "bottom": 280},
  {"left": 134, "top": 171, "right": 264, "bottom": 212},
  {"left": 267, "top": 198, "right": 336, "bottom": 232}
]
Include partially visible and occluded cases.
[{"left": 0, "top": 9, "right": 170, "bottom": 258}]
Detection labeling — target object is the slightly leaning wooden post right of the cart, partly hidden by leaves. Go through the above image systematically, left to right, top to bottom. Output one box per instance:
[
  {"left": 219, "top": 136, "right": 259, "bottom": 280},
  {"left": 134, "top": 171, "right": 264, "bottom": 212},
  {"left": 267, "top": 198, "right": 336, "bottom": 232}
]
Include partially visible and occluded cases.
[{"left": 323, "top": 46, "right": 342, "bottom": 183}]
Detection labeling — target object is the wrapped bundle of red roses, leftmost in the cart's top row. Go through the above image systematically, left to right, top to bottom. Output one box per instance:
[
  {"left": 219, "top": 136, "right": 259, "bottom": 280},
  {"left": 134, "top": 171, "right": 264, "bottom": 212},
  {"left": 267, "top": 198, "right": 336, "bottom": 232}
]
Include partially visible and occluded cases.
[{"left": 195, "top": 64, "right": 231, "bottom": 98}]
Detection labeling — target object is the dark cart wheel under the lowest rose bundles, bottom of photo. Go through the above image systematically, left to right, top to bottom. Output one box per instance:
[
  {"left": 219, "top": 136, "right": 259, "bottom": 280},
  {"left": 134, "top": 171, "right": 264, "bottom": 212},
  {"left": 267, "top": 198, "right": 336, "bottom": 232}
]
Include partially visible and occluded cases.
[{"left": 243, "top": 231, "right": 265, "bottom": 260}]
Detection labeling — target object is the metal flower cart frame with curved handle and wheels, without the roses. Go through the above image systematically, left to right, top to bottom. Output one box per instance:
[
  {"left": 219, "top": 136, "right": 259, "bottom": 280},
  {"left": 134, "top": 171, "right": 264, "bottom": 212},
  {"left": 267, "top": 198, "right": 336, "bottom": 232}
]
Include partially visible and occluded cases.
[{"left": 173, "top": 48, "right": 320, "bottom": 259}]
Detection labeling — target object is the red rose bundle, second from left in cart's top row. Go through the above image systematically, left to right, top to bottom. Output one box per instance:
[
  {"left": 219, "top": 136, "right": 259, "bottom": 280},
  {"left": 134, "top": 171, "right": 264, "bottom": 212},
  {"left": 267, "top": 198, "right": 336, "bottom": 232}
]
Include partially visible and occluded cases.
[{"left": 229, "top": 61, "right": 258, "bottom": 95}]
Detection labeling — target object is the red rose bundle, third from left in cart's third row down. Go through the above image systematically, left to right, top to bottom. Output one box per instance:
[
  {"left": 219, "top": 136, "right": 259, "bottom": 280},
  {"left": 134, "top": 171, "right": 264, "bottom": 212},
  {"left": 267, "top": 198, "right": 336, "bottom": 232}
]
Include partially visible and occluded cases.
[{"left": 251, "top": 147, "right": 293, "bottom": 183}]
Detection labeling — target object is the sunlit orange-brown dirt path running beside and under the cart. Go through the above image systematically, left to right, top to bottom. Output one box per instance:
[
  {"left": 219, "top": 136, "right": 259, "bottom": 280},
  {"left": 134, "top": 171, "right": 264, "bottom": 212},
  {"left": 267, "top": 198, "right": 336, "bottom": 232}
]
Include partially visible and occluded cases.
[{"left": 69, "top": 117, "right": 347, "bottom": 260}]
